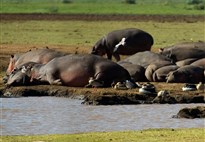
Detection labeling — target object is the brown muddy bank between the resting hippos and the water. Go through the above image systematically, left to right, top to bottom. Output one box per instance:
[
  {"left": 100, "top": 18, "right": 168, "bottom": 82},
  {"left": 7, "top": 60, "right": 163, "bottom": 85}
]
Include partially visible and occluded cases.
[{"left": 0, "top": 83, "right": 205, "bottom": 105}]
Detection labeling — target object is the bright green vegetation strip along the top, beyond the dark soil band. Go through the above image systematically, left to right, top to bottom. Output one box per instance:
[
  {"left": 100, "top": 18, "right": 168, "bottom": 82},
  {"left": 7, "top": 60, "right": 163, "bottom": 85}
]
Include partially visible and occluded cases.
[{"left": 0, "top": 0, "right": 205, "bottom": 15}]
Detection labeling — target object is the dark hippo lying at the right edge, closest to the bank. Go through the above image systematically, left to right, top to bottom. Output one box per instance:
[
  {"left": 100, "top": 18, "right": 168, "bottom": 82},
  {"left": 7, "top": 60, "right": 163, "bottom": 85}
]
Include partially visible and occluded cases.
[{"left": 167, "top": 65, "right": 204, "bottom": 83}]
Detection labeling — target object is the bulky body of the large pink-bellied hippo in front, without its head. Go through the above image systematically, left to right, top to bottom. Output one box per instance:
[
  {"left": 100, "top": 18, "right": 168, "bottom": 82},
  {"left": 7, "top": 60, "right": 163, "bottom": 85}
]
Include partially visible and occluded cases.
[{"left": 44, "top": 54, "right": 131, "bottom": 87}]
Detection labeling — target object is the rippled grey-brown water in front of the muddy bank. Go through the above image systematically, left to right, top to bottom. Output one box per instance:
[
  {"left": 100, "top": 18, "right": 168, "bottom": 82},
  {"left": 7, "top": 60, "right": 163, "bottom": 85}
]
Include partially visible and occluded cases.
[{"left": 0, "top": 97, "right": 205, "bottom": 135}]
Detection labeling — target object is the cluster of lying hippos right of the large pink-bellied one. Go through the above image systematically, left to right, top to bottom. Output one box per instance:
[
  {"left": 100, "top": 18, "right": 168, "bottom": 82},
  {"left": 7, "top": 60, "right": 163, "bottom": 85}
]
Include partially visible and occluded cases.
[{"left": 118, "top": 41, "right": 205, "bottom": 83}]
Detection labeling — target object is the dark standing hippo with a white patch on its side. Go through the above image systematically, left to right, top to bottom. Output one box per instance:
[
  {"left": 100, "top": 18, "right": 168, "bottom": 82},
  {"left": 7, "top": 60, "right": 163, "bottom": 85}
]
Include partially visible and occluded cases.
[{"left": 91, "top": 28, "right": 154, "bottom": 61}]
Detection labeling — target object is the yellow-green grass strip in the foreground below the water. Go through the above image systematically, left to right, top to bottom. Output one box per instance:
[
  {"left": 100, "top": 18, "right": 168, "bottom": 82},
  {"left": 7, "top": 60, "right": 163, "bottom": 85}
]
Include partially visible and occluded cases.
[{"left": 0, "top": 128, "right": 205, "bottom": 142}]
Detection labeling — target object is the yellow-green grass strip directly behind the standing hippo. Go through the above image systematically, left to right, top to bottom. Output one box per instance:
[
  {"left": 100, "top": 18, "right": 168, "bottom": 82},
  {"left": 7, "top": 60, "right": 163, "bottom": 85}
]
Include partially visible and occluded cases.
[{"left": 0, "top": 21, "right": 205, "bottom": 48}]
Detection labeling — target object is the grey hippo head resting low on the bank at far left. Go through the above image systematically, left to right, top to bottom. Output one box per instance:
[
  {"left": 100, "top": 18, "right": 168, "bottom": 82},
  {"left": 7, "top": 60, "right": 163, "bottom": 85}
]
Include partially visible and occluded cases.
[{"left": 6, "top": 68, "right": 30, "bottom": 86}]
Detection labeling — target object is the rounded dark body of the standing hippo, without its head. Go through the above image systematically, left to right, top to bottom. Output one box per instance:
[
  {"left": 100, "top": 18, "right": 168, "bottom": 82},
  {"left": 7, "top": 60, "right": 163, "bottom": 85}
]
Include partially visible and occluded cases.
[{"left": 106, "top": 28, "right": 154, "bottom": 55}]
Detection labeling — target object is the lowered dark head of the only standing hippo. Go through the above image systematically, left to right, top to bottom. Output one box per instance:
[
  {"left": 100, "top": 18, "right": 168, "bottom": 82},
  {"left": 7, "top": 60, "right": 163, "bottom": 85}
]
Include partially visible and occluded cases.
[{"left": 91, "top": 38, "right": 107, "bottom": 56}]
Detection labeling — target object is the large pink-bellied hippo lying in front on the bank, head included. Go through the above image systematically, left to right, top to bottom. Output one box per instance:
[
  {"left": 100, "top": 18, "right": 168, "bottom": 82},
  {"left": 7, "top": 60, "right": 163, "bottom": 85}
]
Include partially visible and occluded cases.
[{"left": 7, "top": 54, "right": 134, "bottom": 87}]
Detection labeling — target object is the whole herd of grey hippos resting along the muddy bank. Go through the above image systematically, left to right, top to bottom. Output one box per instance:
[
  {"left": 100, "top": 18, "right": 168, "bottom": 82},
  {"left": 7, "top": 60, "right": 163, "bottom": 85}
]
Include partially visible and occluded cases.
[{"left": 4, "top": 28, "right": 205, "bottom": 88}]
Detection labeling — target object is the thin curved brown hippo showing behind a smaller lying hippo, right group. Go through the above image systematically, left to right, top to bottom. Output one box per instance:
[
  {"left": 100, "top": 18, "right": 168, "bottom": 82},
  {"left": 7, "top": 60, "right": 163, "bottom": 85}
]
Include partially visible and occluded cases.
[{"left": 145, "top": 60, "right": 173, "bottom": 81}]
